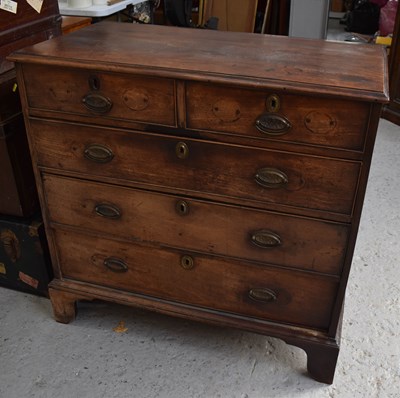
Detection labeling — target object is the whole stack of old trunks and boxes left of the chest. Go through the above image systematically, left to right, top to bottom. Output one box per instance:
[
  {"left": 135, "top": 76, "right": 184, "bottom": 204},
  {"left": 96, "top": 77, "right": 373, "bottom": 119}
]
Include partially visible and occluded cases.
[{"left": 0, "top": 0, "right": 61, "bottom": 294}]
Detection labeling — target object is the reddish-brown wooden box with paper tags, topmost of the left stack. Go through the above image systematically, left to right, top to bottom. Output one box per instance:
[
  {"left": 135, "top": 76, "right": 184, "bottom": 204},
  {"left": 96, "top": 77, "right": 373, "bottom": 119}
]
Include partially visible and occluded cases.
[{"left": 0, "top": 0, "right": 61, "bottom": 73}]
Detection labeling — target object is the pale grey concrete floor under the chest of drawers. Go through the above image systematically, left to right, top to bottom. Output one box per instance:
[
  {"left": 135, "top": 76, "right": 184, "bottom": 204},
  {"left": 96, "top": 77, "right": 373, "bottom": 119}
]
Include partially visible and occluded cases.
[{"left": 0, "top": 120, "right": 400, "bottom": 398}]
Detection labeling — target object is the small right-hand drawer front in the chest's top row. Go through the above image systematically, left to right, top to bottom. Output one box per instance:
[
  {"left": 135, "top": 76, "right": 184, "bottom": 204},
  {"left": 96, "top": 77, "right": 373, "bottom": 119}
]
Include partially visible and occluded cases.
[{"left": 186, "top": 83, "right": 370, "bottom": 151}]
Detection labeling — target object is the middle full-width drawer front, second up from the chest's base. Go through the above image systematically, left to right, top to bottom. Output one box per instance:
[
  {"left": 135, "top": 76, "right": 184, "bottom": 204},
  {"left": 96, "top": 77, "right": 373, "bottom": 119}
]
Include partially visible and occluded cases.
[{"left": 43, "top": 175, "right": 348, "bottom": 274}]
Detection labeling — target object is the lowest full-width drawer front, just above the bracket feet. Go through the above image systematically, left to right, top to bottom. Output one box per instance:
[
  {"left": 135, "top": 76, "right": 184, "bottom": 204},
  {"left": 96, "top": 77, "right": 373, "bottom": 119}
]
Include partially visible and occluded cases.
[{"left": 56, "top": 230, "right": 337, "bottom": 329}]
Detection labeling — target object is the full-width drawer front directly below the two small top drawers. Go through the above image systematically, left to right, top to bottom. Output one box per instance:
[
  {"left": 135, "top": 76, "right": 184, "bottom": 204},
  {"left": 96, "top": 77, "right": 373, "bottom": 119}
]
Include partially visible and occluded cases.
[{"left": 31, "top": 120, "right": 361, "bottom": 214}]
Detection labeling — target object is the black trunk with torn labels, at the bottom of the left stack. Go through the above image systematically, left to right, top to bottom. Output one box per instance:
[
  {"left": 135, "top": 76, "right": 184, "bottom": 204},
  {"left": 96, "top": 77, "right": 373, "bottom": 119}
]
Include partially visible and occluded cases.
[{"left": 0, "top": 211, "right": 52, "bottom": 296}]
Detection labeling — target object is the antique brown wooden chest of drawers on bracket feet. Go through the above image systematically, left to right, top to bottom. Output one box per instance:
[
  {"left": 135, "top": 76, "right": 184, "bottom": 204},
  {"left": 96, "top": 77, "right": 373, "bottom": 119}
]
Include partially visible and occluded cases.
[{"left": 12, "top": 23, "right": 387, "bottom": 383}]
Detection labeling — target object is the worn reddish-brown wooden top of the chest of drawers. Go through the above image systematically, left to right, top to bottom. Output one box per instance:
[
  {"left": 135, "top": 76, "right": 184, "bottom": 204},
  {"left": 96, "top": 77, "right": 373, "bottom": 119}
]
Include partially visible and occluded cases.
[{"left": 11, "top": 22, "right": 388, "bottom": 102}]
